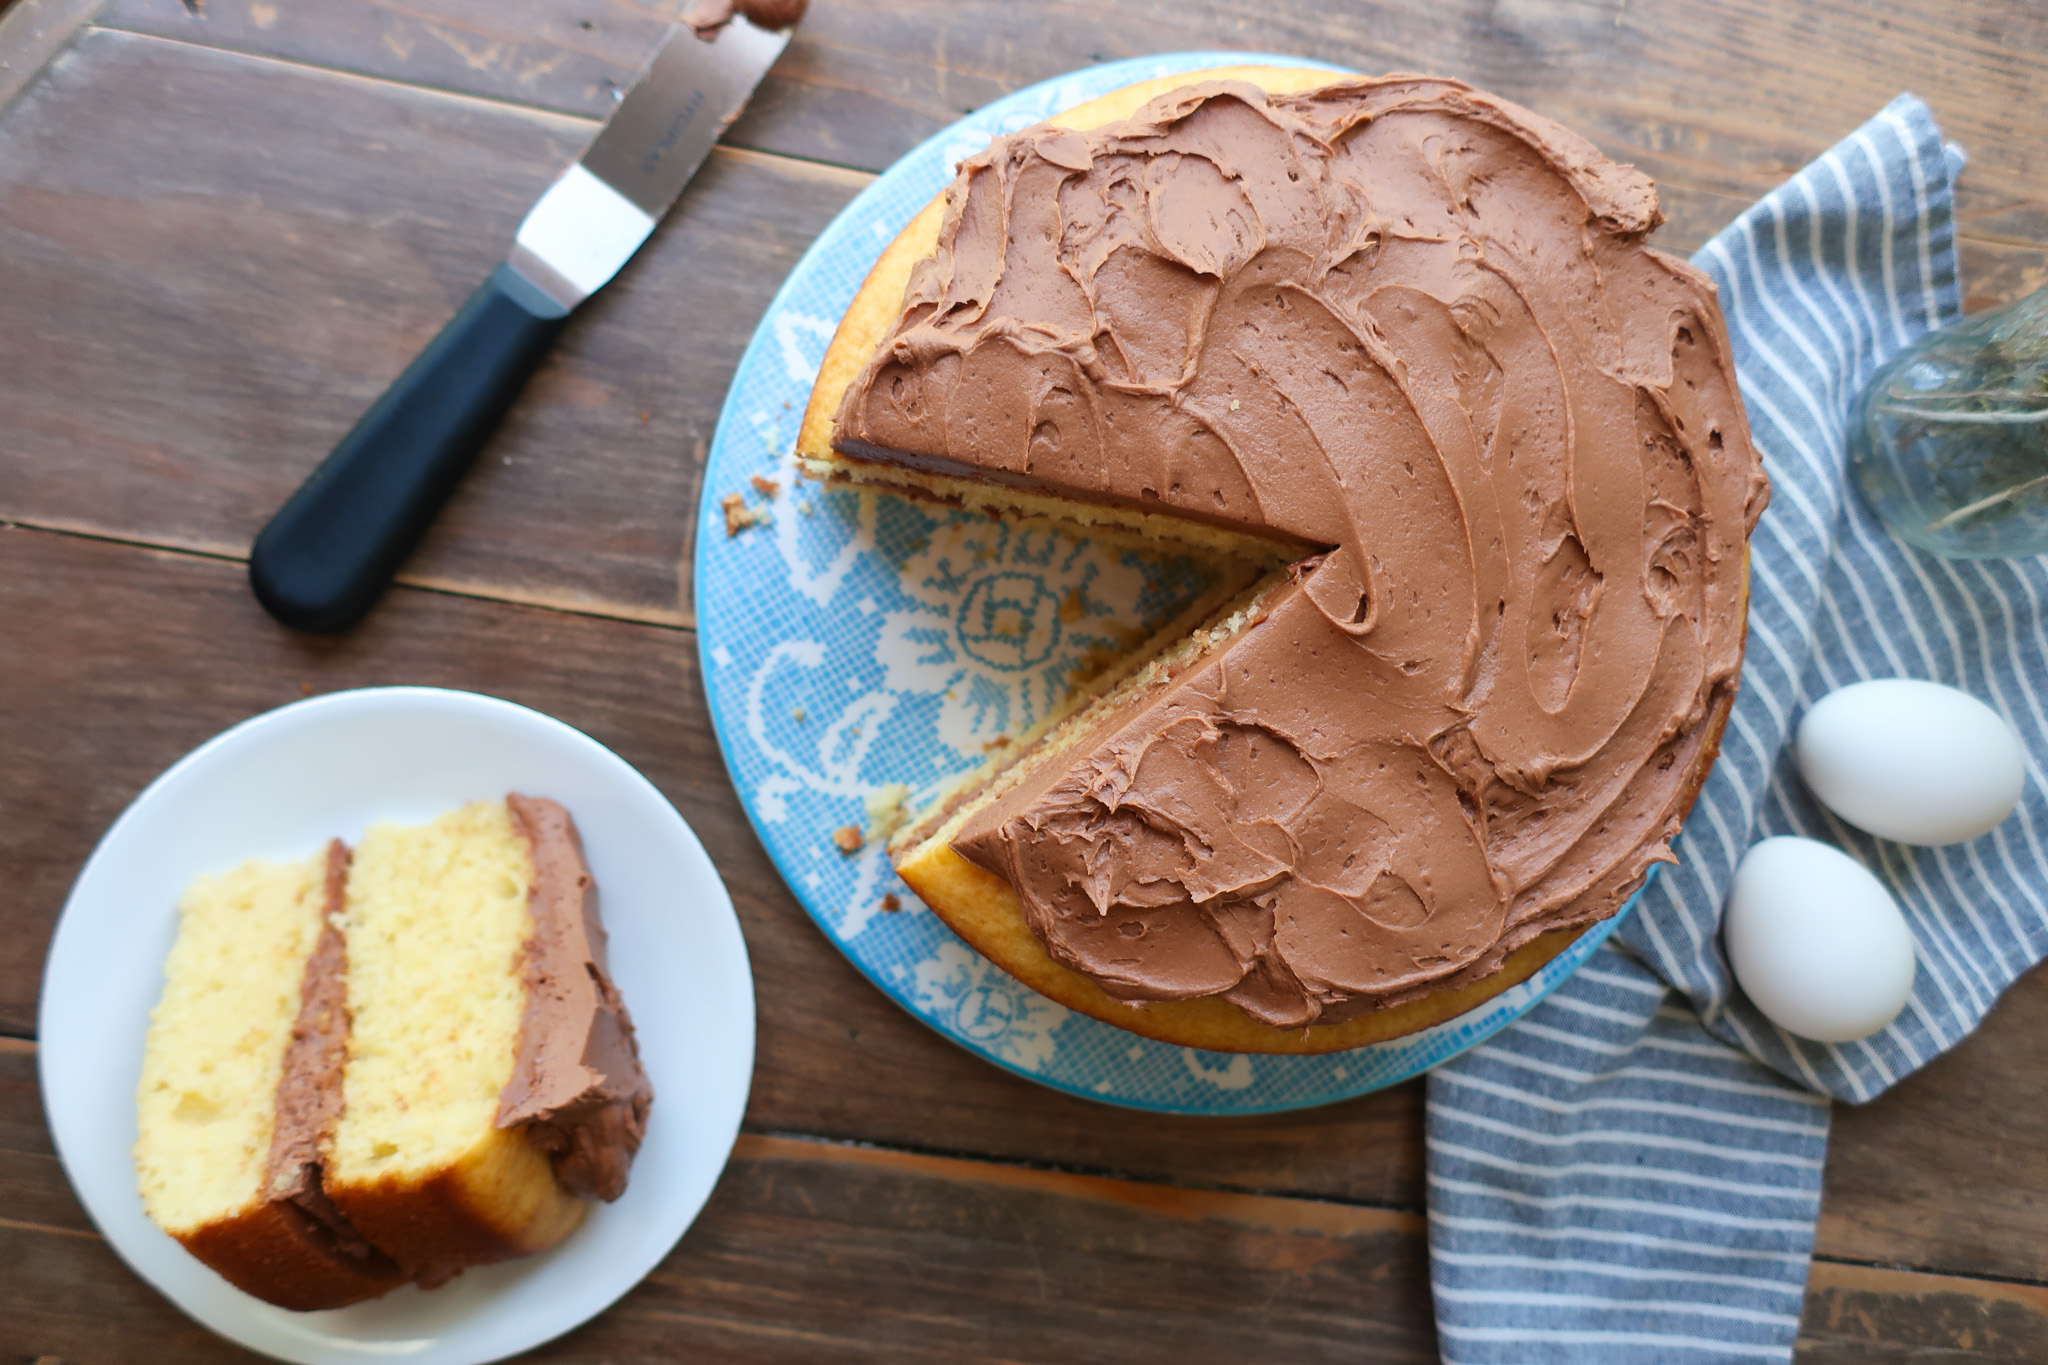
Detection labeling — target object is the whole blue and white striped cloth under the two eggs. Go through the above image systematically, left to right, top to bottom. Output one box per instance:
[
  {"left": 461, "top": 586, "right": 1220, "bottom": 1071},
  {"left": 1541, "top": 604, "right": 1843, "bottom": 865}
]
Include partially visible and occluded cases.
[{"left": 1430, "top": 96, "right": 2048, "bottom": 1365}]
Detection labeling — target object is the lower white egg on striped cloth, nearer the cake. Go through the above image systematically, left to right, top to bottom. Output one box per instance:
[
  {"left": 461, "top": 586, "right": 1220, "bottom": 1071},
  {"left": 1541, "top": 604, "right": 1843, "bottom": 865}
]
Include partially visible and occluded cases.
[{"left": 1720, "top": 837, "right": 1915, "bottom": 1044}]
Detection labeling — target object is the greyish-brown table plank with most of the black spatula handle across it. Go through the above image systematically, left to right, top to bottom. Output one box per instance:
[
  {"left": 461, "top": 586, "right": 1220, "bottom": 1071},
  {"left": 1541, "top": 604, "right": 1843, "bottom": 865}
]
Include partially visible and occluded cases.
[{"left": 0, "top": 29, "right": 864, "bottom": 622}]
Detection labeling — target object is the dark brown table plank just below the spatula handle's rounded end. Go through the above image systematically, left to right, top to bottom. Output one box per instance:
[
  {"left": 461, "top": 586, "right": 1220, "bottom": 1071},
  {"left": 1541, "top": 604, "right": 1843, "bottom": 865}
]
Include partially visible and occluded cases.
[{"left": 19, "top": 530, "right": 2048, "bottom": 1279}]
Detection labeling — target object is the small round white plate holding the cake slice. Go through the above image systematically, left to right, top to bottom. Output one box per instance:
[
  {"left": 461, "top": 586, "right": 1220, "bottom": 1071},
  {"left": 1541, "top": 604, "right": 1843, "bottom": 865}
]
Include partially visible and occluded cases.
[{"left": 39, "top": 688, "right": 754, "bottom": 1365}]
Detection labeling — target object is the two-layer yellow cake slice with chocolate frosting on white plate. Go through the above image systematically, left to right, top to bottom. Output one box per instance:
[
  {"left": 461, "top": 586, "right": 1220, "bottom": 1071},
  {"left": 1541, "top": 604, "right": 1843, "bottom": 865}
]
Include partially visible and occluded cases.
[{"left": 135, "top": 796, "right": 651, "bottom": 1308}]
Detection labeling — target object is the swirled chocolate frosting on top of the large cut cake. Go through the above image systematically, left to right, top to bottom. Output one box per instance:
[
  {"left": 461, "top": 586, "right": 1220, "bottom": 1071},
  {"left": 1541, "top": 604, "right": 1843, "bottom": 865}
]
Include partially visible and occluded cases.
[{"left": 836, "top": 76, "right": 1767, "bottom": 1027}]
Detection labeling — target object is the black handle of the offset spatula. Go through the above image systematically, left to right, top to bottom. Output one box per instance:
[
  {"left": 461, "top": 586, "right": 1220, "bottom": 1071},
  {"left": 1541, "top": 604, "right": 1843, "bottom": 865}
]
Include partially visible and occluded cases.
[{"left": 250, "top": 266, "right": 569, "bottom": 630}]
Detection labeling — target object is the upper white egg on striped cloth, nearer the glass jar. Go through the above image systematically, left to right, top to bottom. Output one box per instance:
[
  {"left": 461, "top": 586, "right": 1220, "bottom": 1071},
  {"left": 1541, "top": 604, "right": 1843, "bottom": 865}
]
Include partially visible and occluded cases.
[{"left": 1796, "top": 677, "right": 2028, "bottom": 845}]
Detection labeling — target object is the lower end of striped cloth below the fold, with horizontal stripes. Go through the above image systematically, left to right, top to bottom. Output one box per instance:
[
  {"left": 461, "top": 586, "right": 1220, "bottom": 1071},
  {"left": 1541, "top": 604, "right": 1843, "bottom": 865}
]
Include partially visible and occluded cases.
[{"left": 1430, "top": 957, "right": 1827, "bottom": 1365}]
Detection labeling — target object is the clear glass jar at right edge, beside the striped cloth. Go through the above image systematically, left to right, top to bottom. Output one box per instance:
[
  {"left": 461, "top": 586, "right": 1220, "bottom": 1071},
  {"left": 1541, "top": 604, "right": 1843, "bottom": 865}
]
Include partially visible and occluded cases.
[{"left": 1849, "top": 289, "right": 2048, "bottom": 559}]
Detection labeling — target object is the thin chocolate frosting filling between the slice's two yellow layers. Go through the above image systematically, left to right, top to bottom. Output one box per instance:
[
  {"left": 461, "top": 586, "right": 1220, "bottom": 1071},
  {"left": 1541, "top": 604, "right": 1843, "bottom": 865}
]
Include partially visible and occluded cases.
[{"left": 264, "top": 839, "right": 403, "bottom": 1283}]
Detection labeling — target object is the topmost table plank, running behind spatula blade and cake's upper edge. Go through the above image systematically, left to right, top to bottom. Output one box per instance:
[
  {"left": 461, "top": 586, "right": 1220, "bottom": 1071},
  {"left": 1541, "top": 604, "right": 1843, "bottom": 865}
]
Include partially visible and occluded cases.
[{"left": 104, "top": 0, "right": 2048, "bottom": 241}]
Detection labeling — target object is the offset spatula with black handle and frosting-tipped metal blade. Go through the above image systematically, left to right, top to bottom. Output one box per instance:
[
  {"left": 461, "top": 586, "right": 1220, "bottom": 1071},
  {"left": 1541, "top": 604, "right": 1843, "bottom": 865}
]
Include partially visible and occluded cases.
[{"left": 250, "top": 4, "right": 803, "bottom": 630}]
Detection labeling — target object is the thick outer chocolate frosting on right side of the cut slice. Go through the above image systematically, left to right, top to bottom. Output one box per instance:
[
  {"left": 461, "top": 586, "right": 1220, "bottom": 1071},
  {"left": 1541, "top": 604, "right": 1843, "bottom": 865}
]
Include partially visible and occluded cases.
[{"left": 498, "top": 796, "right": 653, "bottom": 1199}]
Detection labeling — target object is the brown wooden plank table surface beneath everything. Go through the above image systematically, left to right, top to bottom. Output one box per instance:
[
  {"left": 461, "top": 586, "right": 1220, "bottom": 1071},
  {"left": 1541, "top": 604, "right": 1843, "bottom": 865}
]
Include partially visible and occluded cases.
[{"left": 0, "top": 0, "right": 2048, "bottom": 1365}]
